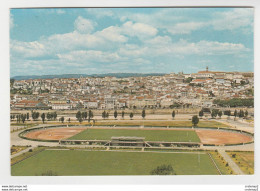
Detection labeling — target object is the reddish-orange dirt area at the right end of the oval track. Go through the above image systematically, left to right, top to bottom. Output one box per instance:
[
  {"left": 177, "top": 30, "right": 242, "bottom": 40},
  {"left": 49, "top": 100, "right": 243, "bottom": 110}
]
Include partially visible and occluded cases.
[{"left": 196, "top": 130, "right": 252, "bottom": 145}]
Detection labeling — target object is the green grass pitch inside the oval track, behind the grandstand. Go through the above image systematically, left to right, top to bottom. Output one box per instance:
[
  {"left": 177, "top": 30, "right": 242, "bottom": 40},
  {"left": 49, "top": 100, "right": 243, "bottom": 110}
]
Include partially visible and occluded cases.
[{"left": 69, "top": 129, "right": 200, "bottom": 142}]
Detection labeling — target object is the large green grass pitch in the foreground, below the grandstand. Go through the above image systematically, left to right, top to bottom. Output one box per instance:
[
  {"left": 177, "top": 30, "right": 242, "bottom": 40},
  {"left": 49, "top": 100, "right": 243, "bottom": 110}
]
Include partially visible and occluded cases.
[{"left": 11, "top": 150, "right": 218, "bottom": 176}]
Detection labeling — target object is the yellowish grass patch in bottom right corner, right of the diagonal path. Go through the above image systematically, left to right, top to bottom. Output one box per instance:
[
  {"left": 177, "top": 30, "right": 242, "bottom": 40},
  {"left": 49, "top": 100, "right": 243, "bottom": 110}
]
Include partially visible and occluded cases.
[{"left": 227, "top": 151, "right": 254, "bottom": 174}]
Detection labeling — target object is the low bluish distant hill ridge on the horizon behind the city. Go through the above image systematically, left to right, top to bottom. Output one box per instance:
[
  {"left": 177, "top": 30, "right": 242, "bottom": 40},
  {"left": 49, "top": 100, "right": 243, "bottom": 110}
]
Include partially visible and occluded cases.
[{"left": 11, "top": 73, "right": 165, "bottom": 80}]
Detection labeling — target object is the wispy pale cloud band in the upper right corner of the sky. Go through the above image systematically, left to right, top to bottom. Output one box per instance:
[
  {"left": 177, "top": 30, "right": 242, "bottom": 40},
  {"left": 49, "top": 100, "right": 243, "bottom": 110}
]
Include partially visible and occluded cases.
[{"left": 114, "top": 8, "right": 253, "bottom": 35}]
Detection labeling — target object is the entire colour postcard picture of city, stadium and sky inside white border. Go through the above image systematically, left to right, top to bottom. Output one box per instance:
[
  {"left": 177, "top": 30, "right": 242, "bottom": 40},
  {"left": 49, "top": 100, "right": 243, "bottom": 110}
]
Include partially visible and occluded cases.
[{"left": 9, "top": 7, "right": 255, "bottom": 176}]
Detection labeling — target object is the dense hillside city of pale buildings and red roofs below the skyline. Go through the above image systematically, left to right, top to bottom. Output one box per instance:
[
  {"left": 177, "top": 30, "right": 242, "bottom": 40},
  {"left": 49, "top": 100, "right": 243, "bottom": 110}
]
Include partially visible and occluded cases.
[{"left": 11, "top": 67, "right": 254, "bottom": 110}]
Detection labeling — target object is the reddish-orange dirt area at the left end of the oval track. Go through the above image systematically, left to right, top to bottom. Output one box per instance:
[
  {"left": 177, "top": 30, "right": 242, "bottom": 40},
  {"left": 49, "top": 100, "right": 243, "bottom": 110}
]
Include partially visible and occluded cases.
[{"left": 25, "top": 127, "right": 86, "bottom": 140}]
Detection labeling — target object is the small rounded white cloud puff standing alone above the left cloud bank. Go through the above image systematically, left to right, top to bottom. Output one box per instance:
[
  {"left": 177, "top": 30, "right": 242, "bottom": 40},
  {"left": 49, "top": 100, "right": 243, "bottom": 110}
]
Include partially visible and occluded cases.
[{"left": 74, "top": 16, "right": 96, "bottom": 33}]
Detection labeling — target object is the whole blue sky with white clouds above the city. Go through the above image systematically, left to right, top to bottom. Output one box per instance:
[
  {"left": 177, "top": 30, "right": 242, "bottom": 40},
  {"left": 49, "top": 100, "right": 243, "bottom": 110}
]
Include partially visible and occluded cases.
[{"left": 10, "top": 8, "right": 254, "bottom": 77}]
